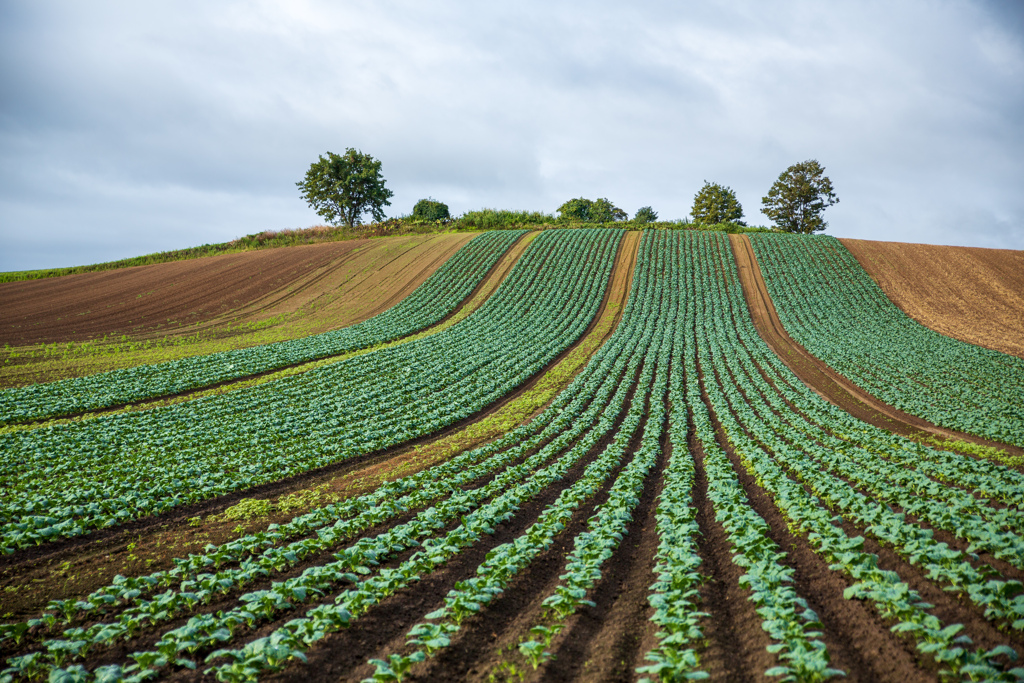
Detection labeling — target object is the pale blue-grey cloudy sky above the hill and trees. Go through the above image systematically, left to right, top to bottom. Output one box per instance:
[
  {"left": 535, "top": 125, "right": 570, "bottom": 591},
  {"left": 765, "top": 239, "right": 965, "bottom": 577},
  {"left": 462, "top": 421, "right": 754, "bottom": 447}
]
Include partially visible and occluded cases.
[{"left": 0, "top": 0, "right": 1024, "bottom": 271}]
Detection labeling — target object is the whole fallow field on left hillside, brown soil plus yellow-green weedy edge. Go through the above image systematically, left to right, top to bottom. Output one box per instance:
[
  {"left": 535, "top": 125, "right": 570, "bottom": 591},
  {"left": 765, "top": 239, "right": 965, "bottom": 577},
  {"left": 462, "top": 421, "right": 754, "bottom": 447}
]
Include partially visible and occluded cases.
[{"left": 0, "top": 233, "right": 473, "bottom": 387}]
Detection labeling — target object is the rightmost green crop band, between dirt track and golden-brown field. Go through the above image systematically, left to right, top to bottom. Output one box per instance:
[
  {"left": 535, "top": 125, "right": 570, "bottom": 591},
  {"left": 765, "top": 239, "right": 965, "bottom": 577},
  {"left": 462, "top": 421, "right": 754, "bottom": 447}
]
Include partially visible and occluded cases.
[{"left": 751, "top": 234, "right": 1024, "bottom": 445}]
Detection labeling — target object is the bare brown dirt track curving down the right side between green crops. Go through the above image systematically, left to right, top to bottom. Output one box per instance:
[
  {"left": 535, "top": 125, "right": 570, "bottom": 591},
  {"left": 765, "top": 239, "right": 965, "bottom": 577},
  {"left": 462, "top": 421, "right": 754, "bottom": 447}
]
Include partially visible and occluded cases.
[{"left": 729, "top": 234, "right": 1024, "bottom": 456}]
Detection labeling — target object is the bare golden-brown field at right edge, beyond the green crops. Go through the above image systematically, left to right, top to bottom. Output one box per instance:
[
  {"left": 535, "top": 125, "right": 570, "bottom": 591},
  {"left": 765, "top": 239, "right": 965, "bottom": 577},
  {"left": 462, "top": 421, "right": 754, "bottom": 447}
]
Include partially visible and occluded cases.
[{"left": 840, "top": 239, "right": 1024, "bottom": 358}]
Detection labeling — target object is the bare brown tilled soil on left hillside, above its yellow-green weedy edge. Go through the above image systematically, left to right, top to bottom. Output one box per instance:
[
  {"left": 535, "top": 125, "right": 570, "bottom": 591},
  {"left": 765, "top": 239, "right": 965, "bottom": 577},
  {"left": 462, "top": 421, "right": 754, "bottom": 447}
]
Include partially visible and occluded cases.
[{"left": 0, "top": 233, "right": 474, "bottom": 346}]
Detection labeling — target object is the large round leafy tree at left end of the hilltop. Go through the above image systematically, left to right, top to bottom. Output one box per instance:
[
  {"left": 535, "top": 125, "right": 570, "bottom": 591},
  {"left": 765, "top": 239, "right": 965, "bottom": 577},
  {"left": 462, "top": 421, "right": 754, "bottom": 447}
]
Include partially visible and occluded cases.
[{"left": 295, "top": 147, "right": 394, "bottom": 227}]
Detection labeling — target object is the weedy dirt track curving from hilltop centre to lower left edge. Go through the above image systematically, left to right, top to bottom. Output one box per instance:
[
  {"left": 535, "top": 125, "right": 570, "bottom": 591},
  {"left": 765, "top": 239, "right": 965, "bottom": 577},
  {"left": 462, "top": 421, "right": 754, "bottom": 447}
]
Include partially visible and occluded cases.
[{"left": 0, "top": 232, "right": 640, "bottom": 617}]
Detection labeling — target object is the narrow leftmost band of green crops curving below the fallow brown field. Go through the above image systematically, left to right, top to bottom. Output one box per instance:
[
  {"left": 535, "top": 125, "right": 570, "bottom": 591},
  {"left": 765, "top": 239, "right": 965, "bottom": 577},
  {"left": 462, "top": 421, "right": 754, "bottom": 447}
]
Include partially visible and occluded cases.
[{"left": 0, "top": 230, "right": 525, "bottom": 425}]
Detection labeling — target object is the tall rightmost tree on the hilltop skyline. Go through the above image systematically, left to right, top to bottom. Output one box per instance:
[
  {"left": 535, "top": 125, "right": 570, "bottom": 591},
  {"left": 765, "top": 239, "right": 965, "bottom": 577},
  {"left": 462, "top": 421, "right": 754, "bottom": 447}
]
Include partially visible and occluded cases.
[{"left": 761, "top": 159, "right": 839, "bottom": 234}]
